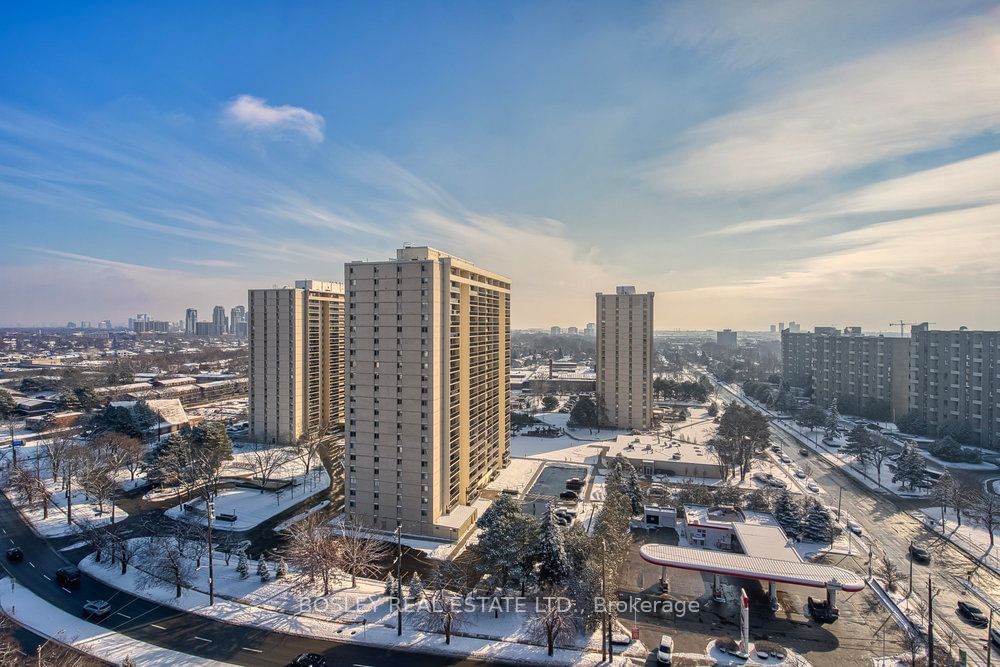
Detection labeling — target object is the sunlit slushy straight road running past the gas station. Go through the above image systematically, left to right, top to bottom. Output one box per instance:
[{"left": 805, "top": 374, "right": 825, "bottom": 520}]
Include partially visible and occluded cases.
[{"left": 717, "top": 383, "right": 1000, "bottom": 665}]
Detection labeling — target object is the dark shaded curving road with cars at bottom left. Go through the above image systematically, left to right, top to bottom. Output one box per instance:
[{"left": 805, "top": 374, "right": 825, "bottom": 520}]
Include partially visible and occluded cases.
[{"left": 0, "top": 495, "right": 503, "bottom": 667}]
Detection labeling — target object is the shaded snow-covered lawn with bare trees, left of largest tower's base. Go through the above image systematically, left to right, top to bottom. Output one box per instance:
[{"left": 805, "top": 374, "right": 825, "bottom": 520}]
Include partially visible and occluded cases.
[{"left": 165, "top": 470, "right": 330, "bottom": 531}]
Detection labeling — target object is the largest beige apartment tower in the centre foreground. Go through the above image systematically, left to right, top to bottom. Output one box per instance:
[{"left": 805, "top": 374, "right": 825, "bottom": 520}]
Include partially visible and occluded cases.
[{"left": 345, "top": 247, "right": 510, "bottom": 539}]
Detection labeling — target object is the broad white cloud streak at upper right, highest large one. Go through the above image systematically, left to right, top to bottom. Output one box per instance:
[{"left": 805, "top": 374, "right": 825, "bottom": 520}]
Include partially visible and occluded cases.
[{"left": 651, "top": 13, "right": 1000, "bottom": 194}]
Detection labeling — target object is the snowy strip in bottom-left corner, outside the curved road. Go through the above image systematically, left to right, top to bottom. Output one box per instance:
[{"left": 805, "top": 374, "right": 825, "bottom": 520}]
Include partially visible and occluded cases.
[{"left": 0, "top": 582, "right": 229, "bottom": 667}]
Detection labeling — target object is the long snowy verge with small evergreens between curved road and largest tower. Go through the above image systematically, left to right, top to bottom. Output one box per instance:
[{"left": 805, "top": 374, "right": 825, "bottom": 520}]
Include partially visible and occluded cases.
[{"left": 80, "top": 540, "right": 646, "bottom": 665}]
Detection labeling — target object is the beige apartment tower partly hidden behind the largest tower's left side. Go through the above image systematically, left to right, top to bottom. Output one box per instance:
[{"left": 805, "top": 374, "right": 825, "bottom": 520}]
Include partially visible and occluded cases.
[{"left": 247, "top": 280, "right": 344, "bottom": 444}]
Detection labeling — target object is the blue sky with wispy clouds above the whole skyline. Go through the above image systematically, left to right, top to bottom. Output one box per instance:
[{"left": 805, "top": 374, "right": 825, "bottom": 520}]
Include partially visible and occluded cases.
[{"left": 0, "top": 0, "right": 1000, "bottom": 329}]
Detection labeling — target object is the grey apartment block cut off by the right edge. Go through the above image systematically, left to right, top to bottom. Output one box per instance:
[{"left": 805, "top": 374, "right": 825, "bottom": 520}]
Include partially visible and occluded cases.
[{"left": 910, "top": 324, "right": 1000, "bottom": 449}]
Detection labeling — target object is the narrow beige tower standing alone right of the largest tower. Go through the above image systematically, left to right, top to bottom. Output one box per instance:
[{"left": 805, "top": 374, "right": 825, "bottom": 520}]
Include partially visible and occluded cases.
[{"left": 597, "top": 286, "right": 653, "bottom": 429}]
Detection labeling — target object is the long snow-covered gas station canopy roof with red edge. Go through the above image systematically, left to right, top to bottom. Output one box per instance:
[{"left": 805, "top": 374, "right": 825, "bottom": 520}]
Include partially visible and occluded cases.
[{"left": 639, "top": 544, "right": 865, "bottom": 592}]
